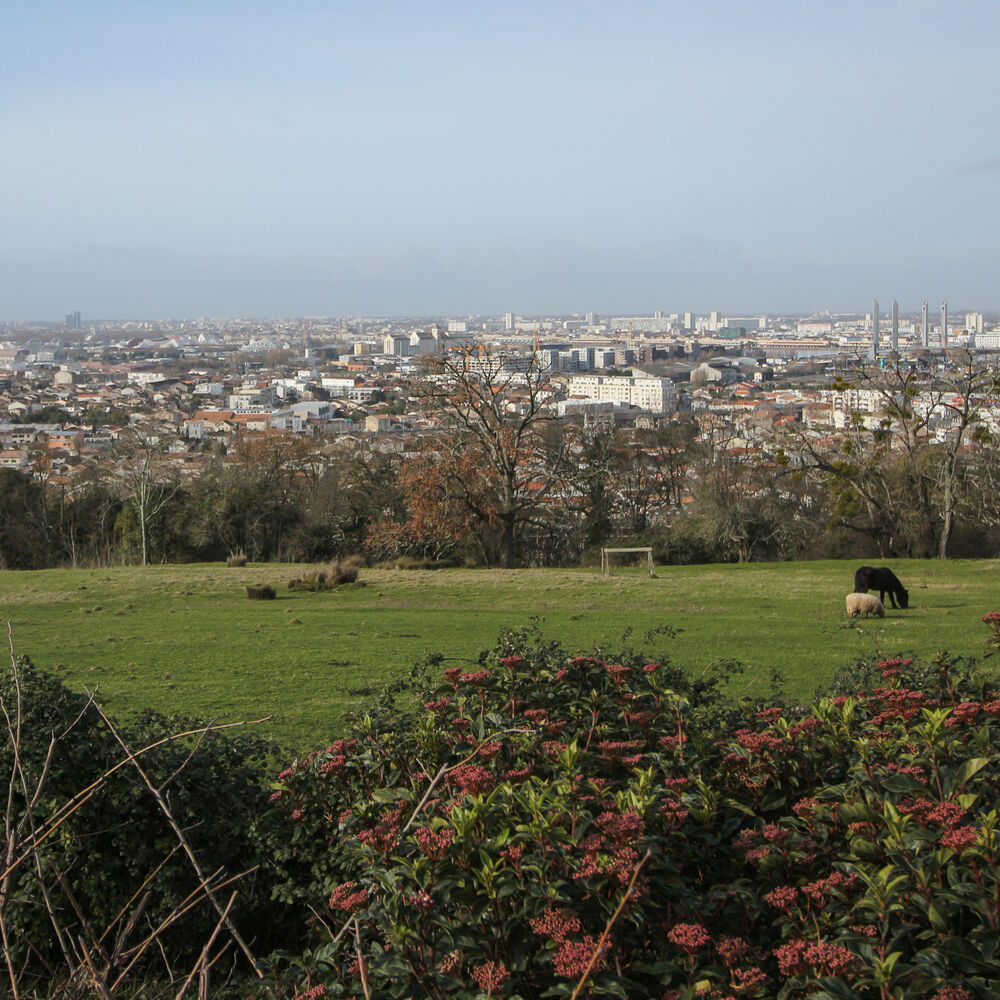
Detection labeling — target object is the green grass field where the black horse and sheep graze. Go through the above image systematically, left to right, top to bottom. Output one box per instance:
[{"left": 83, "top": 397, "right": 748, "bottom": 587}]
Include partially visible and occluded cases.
[{"left": 0, "top": 560, "right": 1000, "bottom": 749}]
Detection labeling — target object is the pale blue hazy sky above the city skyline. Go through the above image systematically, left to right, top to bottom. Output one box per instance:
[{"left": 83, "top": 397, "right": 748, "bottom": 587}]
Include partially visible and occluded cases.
[{"left": 0, "top": 0, "right": 1000, "bottom": 321}]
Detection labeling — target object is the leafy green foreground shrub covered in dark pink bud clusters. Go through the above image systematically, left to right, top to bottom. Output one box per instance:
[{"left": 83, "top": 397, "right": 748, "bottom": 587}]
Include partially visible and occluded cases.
[{"left": 0, "top": 612, "right": 1000, "bottom": 1000}]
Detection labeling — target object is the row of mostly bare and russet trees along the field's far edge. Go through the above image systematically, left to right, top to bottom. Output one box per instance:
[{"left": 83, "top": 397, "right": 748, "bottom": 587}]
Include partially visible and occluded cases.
[{"left": 0, "top": 355, "right": 1000, "bottom": 568}]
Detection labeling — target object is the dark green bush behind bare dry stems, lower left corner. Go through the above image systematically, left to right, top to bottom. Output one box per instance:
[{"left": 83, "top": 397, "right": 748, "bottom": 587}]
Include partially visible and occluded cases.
[{"left": 0, "top": 659, "right": 290, "bottom": 990}]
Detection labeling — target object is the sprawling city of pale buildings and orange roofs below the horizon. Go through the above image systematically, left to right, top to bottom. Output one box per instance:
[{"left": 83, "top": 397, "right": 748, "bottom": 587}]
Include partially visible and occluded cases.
[{"left": 0, "top": 301, "right": 1000, "bottom": 483}]
